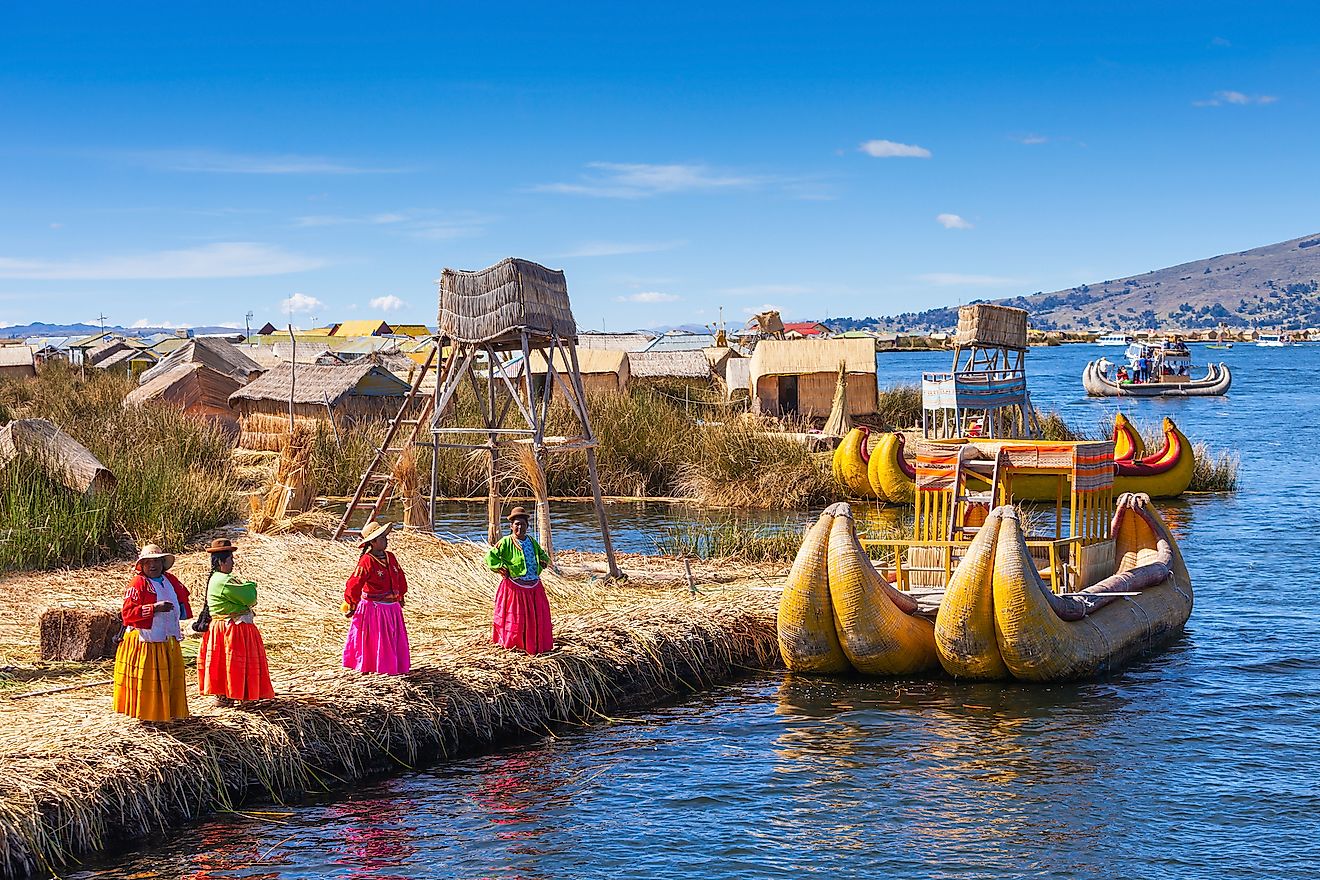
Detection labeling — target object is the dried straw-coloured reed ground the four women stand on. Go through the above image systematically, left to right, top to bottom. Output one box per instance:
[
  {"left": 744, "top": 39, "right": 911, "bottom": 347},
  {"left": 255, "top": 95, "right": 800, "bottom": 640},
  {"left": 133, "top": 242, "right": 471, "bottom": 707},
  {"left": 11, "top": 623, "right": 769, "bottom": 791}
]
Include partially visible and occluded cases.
[{"left": 0, "top": 533, "right": 781, "bottom": 875}]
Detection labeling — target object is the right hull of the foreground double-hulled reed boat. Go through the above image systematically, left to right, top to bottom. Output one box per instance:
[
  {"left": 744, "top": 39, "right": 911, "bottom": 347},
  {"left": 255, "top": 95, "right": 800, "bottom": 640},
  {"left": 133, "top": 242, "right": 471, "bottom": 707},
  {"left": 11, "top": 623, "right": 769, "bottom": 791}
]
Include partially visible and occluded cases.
[{"left": 935, "top": 495, "right": 1192, "bottom": 682}]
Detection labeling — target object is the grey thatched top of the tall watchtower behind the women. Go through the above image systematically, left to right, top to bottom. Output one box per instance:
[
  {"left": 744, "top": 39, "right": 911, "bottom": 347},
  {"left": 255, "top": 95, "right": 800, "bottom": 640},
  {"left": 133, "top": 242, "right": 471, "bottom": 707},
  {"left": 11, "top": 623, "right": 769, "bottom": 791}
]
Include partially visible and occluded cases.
[{"left": 437, "top": 257, "right": 577, "bottom": 346}]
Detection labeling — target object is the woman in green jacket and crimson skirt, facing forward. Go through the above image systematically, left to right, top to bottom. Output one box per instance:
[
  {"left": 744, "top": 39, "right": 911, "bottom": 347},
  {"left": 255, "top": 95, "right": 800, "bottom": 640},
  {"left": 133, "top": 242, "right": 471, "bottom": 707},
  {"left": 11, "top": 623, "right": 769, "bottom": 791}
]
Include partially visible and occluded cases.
[{"left": 486, "top": 507, "right": 554, "bottom": 654}]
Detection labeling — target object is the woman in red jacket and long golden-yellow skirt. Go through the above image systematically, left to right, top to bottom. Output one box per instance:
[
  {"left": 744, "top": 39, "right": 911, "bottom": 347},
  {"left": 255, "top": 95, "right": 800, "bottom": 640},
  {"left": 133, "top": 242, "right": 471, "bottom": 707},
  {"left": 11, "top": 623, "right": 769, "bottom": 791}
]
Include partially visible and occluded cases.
[{"left": 115, "top": 544, "right": 193, "bottom": 722}]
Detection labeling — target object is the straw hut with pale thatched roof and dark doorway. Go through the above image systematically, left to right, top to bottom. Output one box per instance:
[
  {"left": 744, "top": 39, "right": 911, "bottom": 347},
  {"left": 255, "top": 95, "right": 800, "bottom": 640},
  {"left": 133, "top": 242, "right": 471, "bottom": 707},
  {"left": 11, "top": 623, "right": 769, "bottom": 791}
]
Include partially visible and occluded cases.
[{"left": 748, "top": 339, "right": 876, "bottom": 418}]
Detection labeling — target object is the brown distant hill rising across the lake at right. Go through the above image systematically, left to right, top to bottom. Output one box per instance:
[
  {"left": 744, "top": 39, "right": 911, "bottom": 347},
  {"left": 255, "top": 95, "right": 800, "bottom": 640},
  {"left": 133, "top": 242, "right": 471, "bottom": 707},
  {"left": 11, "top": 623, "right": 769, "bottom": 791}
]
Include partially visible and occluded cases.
[{"left": 865, "top": 234, "right": 1320, "bottom": 330}]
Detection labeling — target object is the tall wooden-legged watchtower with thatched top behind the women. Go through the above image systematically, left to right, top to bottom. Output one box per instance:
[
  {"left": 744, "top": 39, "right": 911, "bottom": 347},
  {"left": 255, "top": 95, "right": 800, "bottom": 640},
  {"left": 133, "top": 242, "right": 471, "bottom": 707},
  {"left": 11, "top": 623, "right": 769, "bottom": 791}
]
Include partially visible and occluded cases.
[{"left": 430, "top": 257, "right": 620, "bottom": 577}]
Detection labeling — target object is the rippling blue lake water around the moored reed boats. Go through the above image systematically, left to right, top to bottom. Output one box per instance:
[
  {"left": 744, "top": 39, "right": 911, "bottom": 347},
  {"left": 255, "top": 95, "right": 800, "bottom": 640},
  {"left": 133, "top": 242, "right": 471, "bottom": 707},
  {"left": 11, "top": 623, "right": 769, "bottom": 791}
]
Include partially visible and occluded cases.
[{"left": 66, "top": 346, "right": 1320, "bottom": 880}]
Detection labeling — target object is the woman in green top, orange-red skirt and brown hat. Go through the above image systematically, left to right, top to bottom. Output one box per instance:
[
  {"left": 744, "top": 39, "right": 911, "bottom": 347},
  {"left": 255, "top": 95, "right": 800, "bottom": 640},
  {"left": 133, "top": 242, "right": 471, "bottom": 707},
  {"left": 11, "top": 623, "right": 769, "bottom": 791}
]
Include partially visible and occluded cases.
[{"left": 197, "top": 538, "right": 275, "bottom": 705}]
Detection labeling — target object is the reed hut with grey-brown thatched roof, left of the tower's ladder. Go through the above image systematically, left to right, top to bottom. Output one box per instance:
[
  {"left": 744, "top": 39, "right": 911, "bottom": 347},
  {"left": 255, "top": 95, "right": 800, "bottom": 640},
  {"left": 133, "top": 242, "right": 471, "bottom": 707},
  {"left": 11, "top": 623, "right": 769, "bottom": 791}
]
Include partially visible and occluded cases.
[{"left": 230, "top": 364, "right": 409, "bottom": 451}]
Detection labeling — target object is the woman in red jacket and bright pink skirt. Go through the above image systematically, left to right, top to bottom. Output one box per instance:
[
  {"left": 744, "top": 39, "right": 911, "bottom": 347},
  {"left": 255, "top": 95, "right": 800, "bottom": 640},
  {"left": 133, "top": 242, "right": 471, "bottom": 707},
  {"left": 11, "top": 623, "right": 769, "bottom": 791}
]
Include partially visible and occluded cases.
[{"left": 342, "top": 522, "right": 412, "bottom": 676}]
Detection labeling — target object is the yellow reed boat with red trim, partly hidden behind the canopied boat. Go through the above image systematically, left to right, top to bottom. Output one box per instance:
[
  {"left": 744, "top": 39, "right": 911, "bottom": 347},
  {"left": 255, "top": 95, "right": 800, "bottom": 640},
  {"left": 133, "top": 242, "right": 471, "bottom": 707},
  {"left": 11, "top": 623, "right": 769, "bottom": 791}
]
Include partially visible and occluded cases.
[{"left": 855, "top": 413, "right": 1196, "bottom": 504}]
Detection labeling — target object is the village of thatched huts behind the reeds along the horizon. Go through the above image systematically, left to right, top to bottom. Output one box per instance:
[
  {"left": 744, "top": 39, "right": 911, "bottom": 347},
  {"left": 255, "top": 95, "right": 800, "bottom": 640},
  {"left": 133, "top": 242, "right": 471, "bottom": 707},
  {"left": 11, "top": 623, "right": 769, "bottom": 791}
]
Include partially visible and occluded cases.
[{"left": 0, "top": 311, "right": 1320, "bottom": 451}]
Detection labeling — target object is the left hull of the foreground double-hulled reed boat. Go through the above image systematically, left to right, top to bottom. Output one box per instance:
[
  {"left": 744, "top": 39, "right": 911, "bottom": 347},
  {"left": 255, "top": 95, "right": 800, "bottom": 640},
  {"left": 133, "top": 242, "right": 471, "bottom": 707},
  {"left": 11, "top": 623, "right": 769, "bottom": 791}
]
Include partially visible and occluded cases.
[{"left": 777, "top": 503, "right": 940, "bottom": 676}]
